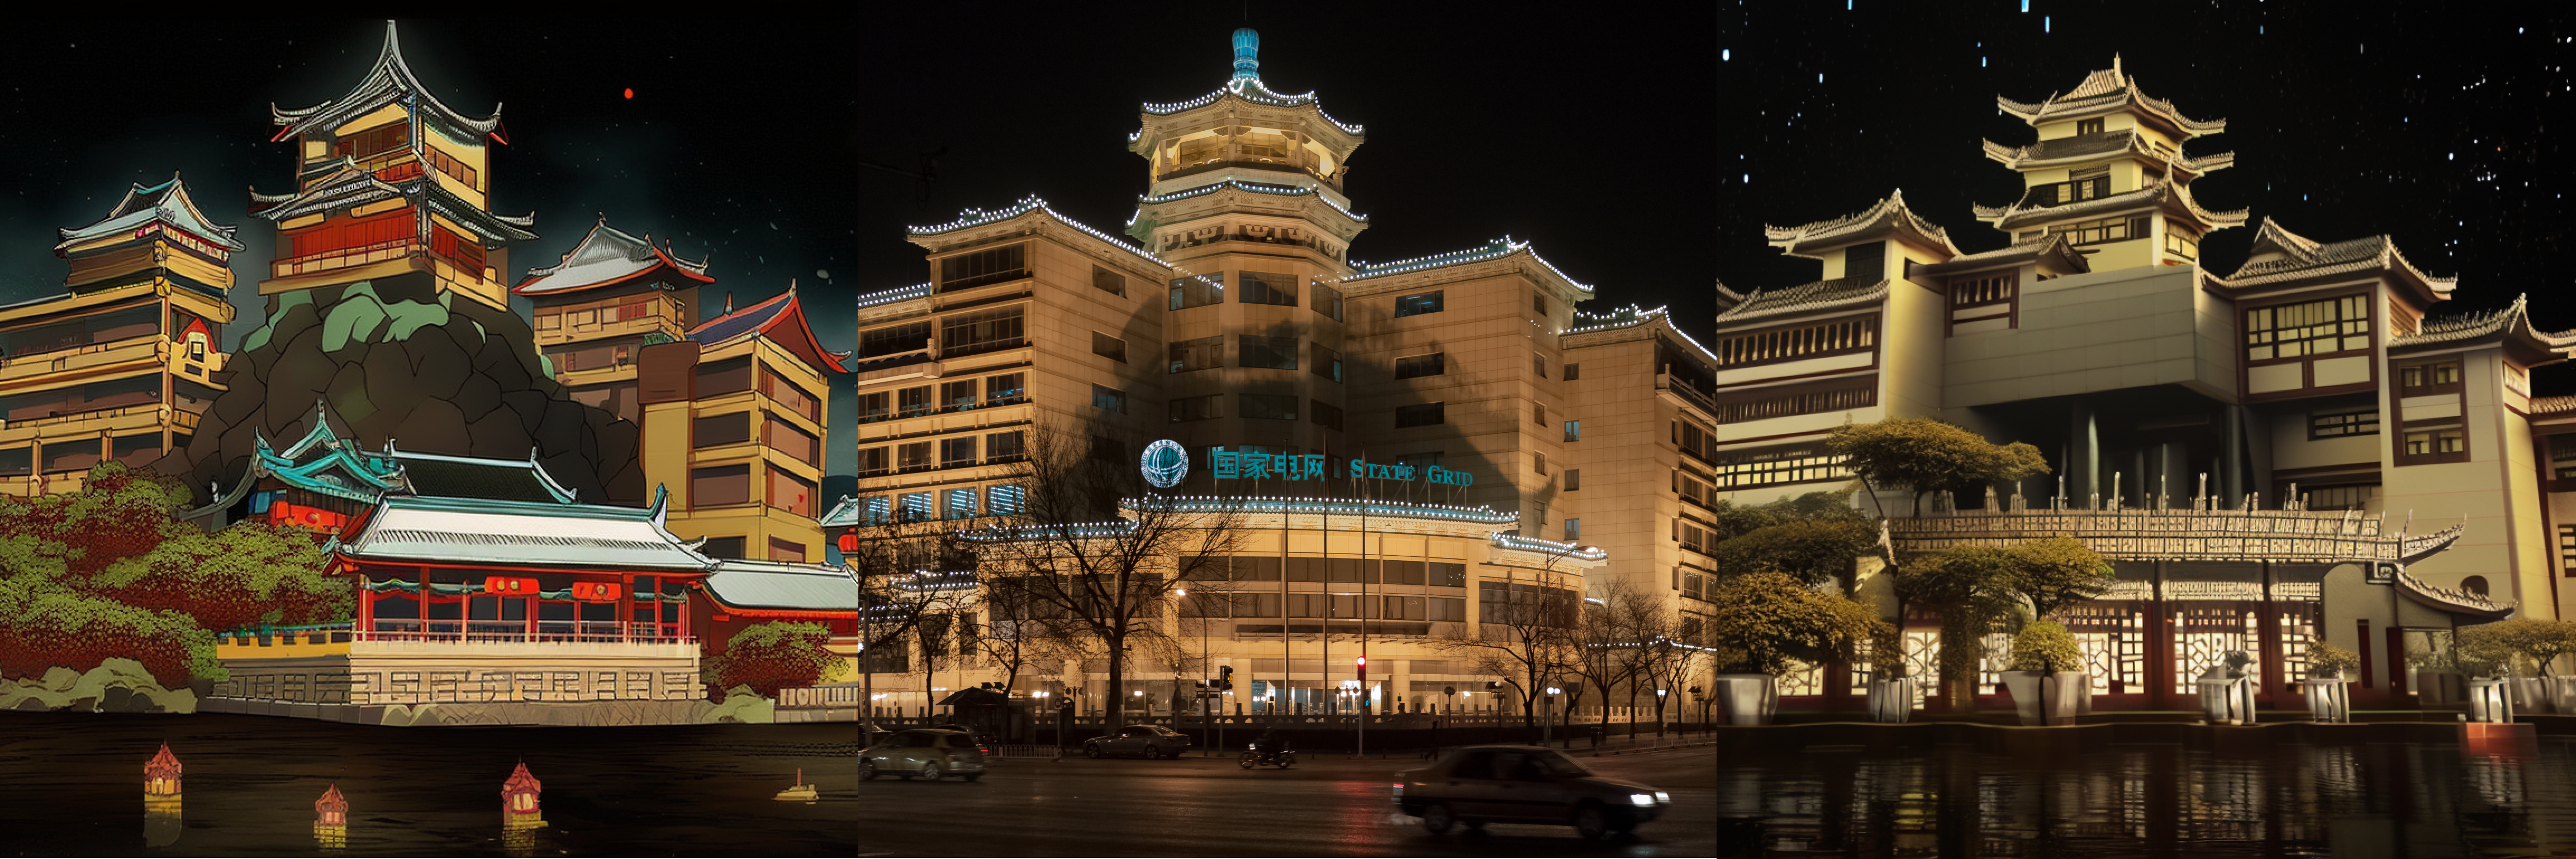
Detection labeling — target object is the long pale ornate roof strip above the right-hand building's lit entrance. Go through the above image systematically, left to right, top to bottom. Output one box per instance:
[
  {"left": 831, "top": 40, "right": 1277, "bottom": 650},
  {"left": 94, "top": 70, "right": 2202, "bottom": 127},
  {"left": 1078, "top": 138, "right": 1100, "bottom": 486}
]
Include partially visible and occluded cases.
[{"left": 1886, "top": 499, "right": 2468, "bottom": 563}]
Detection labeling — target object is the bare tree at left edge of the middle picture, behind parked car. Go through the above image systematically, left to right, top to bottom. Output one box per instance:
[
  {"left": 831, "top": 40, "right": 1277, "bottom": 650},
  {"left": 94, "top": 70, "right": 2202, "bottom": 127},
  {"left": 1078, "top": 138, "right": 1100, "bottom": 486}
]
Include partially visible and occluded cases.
[{"left": 829, "top": 499, "right": 981, "bottom": 731}]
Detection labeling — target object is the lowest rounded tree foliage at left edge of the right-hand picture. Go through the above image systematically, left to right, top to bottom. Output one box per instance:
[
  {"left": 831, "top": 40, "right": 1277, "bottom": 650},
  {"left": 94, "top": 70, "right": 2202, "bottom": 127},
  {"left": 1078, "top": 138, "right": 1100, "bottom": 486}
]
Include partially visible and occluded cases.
[{"left": 1708, "top": 574, "right": 1886, "bottom": 676}]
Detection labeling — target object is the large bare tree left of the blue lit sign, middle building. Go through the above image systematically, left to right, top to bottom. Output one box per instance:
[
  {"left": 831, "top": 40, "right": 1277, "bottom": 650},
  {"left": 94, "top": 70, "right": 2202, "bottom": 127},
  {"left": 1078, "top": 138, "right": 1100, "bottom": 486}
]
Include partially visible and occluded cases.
[{"left": 976, "top": 424, "right": 1242, "bottom": 733}]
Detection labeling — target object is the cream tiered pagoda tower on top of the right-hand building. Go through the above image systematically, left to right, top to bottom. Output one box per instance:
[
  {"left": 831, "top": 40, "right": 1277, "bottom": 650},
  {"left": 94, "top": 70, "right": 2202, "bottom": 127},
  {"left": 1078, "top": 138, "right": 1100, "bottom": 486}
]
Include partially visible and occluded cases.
[{"left": 1976, "top": 56, "right": 2246, "bottom": 270}]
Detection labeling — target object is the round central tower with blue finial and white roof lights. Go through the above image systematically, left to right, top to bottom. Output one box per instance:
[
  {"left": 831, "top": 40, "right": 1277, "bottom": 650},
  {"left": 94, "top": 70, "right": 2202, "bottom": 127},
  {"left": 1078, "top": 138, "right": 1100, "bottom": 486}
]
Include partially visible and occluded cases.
[{"left": 1128, "top": 28, "right": 1368, "bottom": 455}]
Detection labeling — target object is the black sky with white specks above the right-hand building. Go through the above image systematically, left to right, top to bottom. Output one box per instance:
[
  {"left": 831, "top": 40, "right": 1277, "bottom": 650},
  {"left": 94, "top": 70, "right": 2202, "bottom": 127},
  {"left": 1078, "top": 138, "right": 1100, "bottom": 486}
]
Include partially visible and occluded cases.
[{"left": 1713, "top": 0, "right": 2576, "bottom": 394}]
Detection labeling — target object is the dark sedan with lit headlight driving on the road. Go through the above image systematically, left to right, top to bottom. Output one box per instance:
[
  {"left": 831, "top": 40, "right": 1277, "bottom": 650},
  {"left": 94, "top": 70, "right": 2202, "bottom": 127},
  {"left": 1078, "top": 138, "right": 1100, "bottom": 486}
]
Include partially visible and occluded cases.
[{"left": 1394, "top": 746, "right": 1672, "bottom": 838}]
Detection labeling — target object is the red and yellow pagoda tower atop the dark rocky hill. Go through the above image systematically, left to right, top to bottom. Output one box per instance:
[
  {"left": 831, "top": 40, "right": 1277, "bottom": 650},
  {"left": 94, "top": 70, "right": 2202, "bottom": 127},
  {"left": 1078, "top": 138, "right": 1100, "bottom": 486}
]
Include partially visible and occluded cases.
[{"left": 250, "top": 21, "right": 536, "bottom": 309}]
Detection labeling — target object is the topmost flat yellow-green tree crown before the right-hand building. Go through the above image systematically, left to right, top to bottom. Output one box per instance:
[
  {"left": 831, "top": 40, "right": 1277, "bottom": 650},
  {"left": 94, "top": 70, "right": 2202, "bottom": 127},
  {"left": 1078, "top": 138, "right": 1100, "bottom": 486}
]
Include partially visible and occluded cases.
[{"left": 1824, "top": 417, "right": 2048, "bottom": 512}]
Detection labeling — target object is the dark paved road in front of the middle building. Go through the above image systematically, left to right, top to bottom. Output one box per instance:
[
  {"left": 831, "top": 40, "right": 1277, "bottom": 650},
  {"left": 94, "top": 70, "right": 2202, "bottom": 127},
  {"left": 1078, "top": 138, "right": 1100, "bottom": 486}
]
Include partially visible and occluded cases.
[{"left": 856, "top": 748, "right": 1718, "bottom": 856}]
